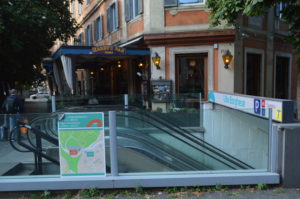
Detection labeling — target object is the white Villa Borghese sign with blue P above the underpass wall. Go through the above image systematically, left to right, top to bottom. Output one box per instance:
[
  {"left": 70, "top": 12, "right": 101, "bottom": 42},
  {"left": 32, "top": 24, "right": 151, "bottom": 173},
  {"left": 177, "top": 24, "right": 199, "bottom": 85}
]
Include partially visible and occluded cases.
[{"left": 208, "top": 91, "right": 294, "bottom": 123}]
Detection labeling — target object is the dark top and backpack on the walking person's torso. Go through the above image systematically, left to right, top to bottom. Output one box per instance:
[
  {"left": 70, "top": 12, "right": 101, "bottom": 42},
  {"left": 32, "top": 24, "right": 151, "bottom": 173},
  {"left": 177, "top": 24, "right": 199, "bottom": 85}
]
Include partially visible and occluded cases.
[{"left": 1, "top": 95, "right": 24, "bottom": 114}]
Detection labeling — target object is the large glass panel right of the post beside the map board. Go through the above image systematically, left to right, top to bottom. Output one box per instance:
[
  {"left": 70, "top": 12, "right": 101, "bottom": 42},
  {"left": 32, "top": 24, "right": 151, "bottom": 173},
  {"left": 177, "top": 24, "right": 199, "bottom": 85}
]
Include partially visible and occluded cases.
[{"left": 113, "top": 105, "right": 268, "bottom": 173}]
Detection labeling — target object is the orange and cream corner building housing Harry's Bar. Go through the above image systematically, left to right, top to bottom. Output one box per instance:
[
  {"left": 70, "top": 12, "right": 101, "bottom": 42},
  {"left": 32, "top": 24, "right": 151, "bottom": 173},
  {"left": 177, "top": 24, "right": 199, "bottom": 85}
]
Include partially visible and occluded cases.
[{"left": 52, "top": 0, "right": 297, "bottom": 102}]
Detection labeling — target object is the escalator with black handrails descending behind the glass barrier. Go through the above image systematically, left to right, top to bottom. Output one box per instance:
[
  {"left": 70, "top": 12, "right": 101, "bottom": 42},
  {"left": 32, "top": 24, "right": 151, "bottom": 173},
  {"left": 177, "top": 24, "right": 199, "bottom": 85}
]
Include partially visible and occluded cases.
[{"left": 3, "top": 106, "right": 254, "bottom": 175}]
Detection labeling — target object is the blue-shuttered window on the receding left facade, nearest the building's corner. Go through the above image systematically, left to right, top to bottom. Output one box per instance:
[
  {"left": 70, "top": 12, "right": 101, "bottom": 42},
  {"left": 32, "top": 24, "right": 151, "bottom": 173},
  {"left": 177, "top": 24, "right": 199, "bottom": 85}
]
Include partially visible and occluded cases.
[{"left": 125, "top": 0, "right": 143, "bottom": 21}]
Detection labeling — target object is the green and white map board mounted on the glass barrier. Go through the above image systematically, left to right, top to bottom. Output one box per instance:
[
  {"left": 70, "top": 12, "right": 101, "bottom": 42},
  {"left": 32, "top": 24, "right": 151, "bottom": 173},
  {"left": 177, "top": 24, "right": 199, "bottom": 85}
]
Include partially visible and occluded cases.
[{"left": 58, "top": 113, "right": 106, "bottom": 176}]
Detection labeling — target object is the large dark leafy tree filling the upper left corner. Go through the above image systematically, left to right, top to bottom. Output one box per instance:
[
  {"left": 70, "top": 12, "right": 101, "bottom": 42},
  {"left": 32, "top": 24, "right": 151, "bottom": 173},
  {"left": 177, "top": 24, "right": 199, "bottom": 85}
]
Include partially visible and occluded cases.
[{"left": 0, "top": 0, "right": 81, "bottom": 90}]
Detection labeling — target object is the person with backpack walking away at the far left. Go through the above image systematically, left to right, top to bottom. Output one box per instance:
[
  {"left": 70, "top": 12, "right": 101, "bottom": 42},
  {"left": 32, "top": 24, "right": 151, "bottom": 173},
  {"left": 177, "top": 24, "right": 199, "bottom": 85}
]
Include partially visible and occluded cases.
[{"left": 1, "top": 89, "right": 24, "bottom": 140}]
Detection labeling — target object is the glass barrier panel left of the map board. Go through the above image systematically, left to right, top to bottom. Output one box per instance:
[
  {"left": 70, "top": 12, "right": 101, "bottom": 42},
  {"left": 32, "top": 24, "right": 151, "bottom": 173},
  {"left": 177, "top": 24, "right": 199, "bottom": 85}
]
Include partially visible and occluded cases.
[{"left": 0, "top": 114, "right": 59, "bottom": 177}]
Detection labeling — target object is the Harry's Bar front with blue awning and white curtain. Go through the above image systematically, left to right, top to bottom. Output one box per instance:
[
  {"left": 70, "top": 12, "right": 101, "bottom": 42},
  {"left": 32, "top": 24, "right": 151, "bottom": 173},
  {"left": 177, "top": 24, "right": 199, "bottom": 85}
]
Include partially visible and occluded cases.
[{"left": 51, "top": 46, "right": 150, "bottom": 96}]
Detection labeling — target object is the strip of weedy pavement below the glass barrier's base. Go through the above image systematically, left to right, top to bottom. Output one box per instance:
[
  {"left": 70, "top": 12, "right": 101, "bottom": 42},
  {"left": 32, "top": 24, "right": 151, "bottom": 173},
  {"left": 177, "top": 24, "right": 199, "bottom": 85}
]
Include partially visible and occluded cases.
[{"left": 0, "top": 187, "right": 300, "bottom": 199}]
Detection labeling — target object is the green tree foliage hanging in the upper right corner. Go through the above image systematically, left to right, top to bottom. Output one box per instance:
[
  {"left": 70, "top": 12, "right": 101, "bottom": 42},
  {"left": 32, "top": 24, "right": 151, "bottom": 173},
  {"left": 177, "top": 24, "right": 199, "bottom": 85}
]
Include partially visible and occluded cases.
[{"left": 206, "top": 0, "right": 300, "bottom": 53}]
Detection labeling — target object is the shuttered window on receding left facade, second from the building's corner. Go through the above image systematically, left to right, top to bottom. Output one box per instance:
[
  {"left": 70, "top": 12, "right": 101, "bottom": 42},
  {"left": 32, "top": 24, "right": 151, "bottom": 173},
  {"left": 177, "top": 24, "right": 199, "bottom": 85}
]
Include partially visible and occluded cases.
[{"left": 106, "top": 1, "right": 119, "bottom": 32}]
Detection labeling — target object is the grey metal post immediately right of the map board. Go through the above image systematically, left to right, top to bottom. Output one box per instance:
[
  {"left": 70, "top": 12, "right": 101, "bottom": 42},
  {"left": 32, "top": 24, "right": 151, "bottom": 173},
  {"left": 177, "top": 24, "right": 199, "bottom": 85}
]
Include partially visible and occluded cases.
[{"left": 108, "top": 111, "right": 119, "bottom": 176}]
